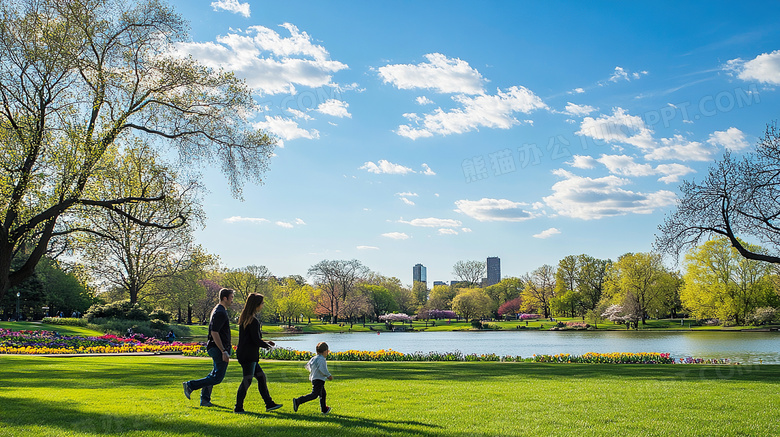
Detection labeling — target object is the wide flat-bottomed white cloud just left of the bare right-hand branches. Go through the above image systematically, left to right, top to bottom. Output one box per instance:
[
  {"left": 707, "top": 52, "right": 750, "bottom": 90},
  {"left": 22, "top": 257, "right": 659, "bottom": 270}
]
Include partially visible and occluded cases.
[{"left": 543, "top": 169, "right": 676, "bottom": 220}]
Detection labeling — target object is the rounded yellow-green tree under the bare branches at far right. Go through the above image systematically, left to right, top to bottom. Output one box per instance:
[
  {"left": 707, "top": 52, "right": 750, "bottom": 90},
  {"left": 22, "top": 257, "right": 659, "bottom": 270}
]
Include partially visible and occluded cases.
[{"left": 680, "top": 238, "right": 775, "bottom": 324}]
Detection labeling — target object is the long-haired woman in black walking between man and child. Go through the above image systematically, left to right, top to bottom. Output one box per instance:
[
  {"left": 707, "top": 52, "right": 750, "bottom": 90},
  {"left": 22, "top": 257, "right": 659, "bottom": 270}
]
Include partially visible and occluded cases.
[{"left": 233, "top": 293, "right": 282, "bottom": 413}]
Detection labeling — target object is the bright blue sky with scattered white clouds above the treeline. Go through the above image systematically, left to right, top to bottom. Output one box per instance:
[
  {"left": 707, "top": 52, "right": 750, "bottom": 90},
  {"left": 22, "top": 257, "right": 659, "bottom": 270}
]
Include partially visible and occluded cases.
[{"left": 171, "top": 0, "right": 780, "bottom": 286}]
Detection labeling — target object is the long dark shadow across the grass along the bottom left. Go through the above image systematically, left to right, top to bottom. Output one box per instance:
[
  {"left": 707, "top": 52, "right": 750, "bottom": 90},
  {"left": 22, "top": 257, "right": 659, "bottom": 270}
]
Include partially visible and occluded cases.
[{"left": 0, "top": 396, "right": 442, "bottom": 437}]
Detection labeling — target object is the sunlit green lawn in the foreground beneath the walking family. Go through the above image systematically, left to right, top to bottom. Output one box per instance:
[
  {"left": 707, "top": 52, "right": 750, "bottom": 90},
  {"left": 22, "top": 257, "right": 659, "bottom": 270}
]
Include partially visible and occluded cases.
[{"left": 0, "top": 355, "right": 780, "bottom": 437}]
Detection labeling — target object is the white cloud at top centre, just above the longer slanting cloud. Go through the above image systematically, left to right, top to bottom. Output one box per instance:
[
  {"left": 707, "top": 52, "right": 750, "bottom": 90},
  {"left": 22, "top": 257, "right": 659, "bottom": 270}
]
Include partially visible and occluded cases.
[{"left": 377, "top": 53, "right": 485, "bottom": 94}]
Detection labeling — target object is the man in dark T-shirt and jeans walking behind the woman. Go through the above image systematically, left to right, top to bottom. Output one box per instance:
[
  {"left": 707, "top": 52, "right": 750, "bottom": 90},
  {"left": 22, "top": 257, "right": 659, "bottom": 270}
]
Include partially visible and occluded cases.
[{"left": 182, "top": 288, "right": 233, "bottom": 407}]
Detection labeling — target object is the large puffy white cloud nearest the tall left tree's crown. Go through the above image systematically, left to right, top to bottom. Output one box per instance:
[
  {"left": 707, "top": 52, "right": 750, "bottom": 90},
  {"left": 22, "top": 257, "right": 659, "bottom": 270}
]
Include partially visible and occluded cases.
[{"left": 174, "top": 23, "right": 348, "bottom": 94}]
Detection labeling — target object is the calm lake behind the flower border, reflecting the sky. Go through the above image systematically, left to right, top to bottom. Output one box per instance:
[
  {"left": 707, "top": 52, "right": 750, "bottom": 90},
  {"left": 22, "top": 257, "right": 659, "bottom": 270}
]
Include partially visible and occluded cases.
[{"left": 268, "top": 331, "right": 780, "bottom": 364}]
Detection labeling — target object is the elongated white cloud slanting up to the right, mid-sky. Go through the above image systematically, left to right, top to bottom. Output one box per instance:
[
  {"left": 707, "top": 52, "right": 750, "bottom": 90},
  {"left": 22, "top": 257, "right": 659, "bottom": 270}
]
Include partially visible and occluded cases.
[{"left": 396, "top": 86, "right": 547, "bottom": 139}]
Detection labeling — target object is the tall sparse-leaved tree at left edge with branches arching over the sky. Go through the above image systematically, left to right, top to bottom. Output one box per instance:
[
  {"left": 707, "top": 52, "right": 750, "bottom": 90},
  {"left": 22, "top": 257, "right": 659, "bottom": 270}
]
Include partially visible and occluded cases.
[{"left": 0, "top": 0, "right": 275, "bottom": 298}]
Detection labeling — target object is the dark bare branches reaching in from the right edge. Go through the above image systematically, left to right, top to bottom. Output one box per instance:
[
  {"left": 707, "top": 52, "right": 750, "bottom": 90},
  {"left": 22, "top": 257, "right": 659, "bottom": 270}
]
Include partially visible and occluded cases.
[{"left": 655, "top": 124, "right": 780, "bottom": 264}]
